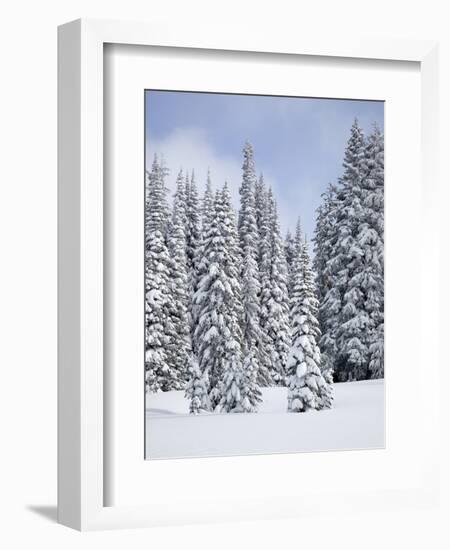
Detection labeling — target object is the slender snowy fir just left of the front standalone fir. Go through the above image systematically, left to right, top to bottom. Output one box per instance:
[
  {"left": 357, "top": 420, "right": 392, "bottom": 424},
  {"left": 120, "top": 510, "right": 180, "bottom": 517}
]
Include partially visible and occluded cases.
[{"left": 260, "top": 190, "right": 291, "bottom": 385}]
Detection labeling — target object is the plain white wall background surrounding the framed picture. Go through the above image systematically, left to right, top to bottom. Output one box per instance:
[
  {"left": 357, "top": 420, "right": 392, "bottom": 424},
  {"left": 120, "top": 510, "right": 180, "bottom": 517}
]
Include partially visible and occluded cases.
[{"left": 0, "top": 0, "right": 450, "bottom": 550}]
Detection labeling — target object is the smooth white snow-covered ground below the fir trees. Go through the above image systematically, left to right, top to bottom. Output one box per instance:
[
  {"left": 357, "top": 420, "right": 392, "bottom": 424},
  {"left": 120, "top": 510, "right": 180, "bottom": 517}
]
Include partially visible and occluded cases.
[{"left": 146, "top": 380, "right": 384, "bottom": 458}]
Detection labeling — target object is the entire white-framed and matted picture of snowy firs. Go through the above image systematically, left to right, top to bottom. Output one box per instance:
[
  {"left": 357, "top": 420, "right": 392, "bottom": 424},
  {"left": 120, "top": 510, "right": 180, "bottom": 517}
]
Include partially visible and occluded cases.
[{"left": 58, "top": 20, "right": 439, "bottom": 530}]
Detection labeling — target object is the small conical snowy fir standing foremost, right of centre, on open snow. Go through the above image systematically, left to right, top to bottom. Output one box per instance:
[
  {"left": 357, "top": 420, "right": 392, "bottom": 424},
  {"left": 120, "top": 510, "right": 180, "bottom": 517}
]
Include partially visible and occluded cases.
[{"left": 287, "top": 242, "right": 333, "bottom": 412}]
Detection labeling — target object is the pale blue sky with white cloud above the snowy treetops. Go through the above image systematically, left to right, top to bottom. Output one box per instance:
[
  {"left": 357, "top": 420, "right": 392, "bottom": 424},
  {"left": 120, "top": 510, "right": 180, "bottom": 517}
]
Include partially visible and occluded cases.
[{"left": 145, "top": 91, "right": 384, "bottom": 237}]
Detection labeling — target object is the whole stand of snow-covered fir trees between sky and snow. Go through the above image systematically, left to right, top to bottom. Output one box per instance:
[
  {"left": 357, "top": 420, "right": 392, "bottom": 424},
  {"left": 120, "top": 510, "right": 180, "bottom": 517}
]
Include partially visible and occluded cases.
[{"left": 145, "top": 118, "right": 384, "bottom": 414}]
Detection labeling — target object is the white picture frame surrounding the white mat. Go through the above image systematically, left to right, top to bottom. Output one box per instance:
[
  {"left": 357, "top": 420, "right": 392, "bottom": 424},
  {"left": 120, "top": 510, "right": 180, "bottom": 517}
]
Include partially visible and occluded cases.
[{"left": 58, "top": 20, "right": 439, "bottom": 530}]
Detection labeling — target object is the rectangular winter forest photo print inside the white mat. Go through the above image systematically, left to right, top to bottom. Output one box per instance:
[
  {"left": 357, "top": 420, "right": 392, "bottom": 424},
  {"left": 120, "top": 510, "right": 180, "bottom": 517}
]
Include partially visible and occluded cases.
[{"left": 143, "top": 90, "right": 385, "bottom": 459}]
